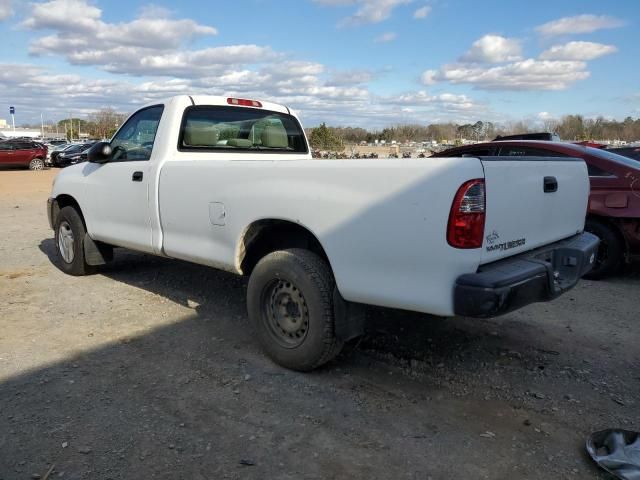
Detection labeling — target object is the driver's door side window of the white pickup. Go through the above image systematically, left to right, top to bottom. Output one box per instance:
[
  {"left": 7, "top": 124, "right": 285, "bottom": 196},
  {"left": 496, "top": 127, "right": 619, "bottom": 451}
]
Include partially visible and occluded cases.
[{"left": 111, "top": 105, "right": 164, "bottom": 162}]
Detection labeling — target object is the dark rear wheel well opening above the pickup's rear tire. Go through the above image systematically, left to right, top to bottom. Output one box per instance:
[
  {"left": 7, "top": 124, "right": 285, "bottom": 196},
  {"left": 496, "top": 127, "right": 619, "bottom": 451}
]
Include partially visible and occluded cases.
[{"left": 237, "top": 219, "right": 331, "bottom": 275}]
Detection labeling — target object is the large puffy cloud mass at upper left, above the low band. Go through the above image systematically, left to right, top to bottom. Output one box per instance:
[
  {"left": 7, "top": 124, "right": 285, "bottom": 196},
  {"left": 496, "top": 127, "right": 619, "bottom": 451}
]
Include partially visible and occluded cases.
[{"left": 23, "top": 0, "right": 298, "bottom": 78}]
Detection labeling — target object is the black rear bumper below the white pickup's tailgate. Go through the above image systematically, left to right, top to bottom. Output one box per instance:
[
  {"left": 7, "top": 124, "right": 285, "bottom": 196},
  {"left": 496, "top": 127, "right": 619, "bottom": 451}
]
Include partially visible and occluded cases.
[{"left": 454, "top": 232, "right": 600, "bottom": 317}]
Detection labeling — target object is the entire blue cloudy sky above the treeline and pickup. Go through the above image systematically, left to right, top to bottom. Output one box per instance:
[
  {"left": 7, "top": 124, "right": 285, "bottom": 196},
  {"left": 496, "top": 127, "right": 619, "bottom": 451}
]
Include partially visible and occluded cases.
[{"left": 0, "top": 0, "right": 640, "bottom": 129}]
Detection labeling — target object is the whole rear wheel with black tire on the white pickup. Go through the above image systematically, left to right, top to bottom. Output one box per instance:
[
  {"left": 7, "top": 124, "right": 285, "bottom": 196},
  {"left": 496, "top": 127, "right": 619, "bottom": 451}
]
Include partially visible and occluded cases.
[{"left": 247, "top": 248, "right": 343, "bottom": 372}]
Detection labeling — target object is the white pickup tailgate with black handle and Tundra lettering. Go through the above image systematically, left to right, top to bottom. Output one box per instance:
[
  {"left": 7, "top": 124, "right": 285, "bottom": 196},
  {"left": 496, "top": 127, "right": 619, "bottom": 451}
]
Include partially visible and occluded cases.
[{"left": 480, "top": 157, "right": 589, "bottom": 264}]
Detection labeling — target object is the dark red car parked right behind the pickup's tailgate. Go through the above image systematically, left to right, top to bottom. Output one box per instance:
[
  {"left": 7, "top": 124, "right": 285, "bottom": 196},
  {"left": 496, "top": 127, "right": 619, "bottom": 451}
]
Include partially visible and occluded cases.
[{"left": 432, "top": 140, "right": 640, "bottom": 279}]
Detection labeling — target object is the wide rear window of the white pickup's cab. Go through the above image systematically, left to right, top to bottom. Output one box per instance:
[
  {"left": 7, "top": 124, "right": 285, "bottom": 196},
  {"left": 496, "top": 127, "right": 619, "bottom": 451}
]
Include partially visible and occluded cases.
[{"left": 178, "top": 106, "right": 308, "bottom": 153}]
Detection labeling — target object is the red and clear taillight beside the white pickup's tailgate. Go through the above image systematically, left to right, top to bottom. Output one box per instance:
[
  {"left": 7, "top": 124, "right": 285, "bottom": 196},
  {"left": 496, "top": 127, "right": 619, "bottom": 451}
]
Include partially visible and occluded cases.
[{"left": 447, "top": 178, "right": 486, "bottom": 248}]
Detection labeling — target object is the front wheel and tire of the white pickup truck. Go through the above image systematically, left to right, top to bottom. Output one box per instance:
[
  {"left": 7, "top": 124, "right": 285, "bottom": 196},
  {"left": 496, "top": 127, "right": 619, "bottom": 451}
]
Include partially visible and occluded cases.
[{"left": 54, "top": 207, "right": 95, "bottom": 276}]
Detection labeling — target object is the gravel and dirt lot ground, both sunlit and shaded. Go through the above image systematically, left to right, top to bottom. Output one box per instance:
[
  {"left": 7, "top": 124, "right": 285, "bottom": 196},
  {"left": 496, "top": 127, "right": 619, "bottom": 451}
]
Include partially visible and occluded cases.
[{"left": 0, "top": 171, "right": 640, "bottom": 480}]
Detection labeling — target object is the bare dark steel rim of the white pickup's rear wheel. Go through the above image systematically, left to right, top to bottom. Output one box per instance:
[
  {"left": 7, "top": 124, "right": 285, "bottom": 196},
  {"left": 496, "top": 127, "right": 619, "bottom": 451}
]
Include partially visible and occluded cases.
[{"left": 263, "top": 280, "right": 309, "bottom": 348}]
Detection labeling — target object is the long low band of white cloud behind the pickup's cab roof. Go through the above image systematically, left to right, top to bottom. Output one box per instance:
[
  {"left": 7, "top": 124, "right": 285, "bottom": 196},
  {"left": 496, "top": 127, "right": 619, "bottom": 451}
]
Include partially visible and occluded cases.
[{"left": 0, "top": 62, "right": 490, "bottom": 128}]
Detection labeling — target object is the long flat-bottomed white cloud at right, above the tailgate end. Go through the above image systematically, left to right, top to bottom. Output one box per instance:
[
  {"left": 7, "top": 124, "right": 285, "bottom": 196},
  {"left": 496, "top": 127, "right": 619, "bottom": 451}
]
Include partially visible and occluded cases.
[{"left": 433, "top": 58, "right": 589, "bottom": 90}]
